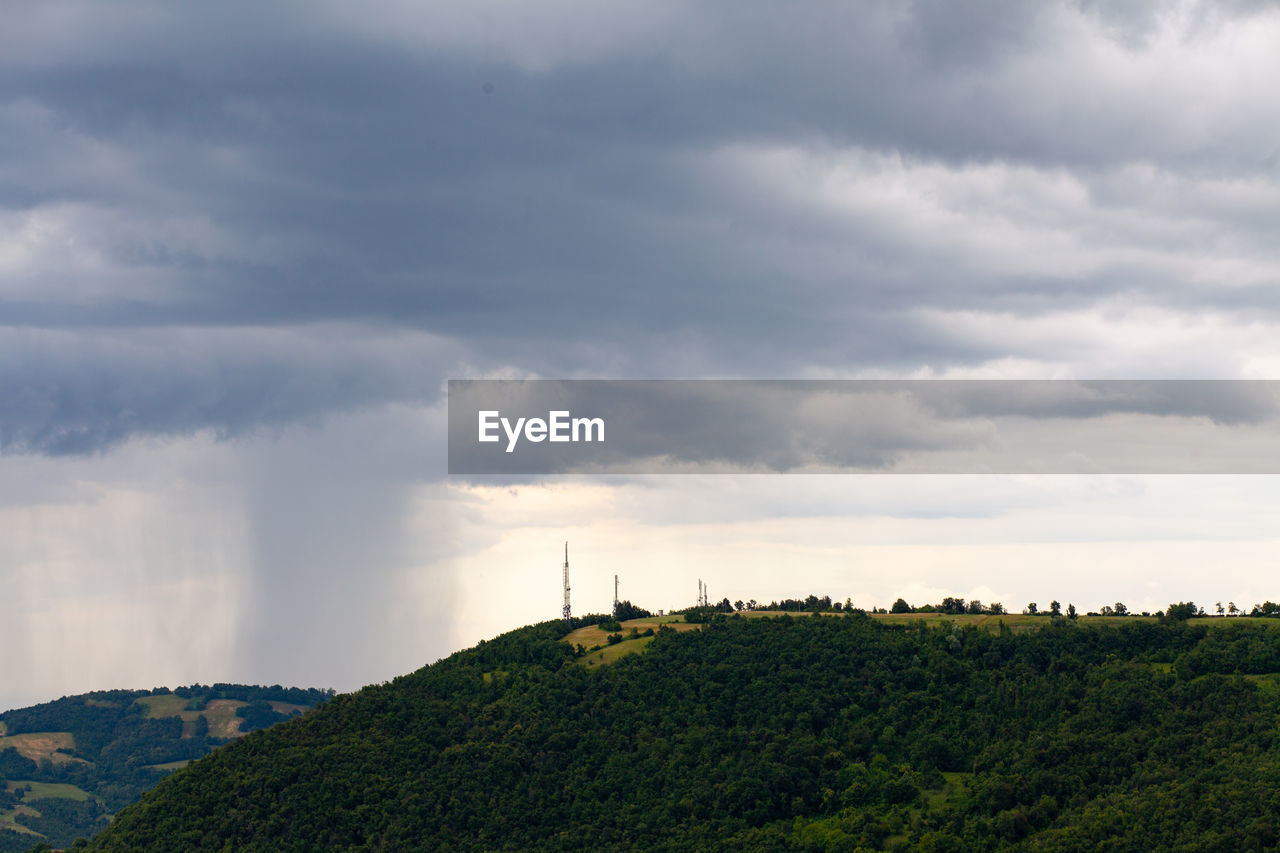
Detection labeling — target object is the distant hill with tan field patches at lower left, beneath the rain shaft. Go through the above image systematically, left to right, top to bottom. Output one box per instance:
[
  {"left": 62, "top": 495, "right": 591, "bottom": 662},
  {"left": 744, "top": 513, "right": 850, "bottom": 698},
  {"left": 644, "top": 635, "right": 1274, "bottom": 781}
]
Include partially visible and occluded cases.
[{"left": 0, "top": 684, "right": 333, "bottom": 853}]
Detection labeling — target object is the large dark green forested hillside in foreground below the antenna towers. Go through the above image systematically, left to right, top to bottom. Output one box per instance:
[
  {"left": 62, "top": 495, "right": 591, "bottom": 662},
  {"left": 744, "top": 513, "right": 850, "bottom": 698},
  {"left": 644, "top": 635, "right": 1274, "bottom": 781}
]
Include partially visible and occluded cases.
[{"left": 72, "top": 613, "right": 1280, "bottom": 850}]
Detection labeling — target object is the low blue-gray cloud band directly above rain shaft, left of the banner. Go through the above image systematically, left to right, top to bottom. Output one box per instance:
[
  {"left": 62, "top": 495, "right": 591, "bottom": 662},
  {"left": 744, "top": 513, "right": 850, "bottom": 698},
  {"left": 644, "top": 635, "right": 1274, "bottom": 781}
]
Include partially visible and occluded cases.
[{"left": 0, "top": 327, "right": 447, "bottom": 455}]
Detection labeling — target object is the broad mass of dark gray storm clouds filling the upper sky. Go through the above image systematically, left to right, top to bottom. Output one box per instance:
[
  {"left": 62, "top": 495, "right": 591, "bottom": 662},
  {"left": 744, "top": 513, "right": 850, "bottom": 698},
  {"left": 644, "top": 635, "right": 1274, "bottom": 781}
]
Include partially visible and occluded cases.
[{"left": 0, "top": 0, "right": 1280, "bottom": 453}]
